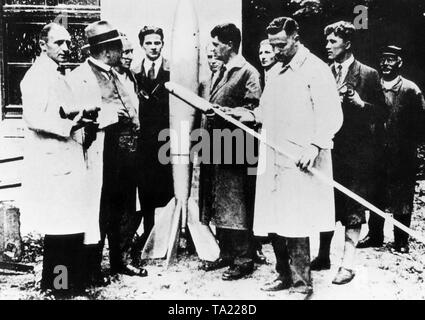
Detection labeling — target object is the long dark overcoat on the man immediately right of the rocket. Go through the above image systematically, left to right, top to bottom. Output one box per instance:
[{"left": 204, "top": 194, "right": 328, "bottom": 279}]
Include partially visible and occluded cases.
[{"left": 199, "top": 56, "right": 261, "bottom": 230}]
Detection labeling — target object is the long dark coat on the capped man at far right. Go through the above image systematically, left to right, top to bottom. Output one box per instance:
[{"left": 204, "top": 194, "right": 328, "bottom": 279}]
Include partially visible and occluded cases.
[{"left": 380, "top": 77, "right": 425, "bottom": 214}]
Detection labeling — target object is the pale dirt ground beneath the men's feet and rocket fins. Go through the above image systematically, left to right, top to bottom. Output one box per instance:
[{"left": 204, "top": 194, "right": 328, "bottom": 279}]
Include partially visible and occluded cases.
[{"left": 0, "top": 192, "right": 425, "bottom": 300}]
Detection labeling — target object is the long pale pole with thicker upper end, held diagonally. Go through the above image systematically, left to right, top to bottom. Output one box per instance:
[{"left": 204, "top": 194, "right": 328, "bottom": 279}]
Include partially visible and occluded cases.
[{"left": 165, "top": 82, "right": 425, "bottom": 244}]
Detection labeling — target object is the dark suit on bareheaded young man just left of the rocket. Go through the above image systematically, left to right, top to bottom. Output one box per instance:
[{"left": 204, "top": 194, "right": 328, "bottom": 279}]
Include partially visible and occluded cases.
[{"left": 133, "top": 59, "right": 174, "bottom": 210}]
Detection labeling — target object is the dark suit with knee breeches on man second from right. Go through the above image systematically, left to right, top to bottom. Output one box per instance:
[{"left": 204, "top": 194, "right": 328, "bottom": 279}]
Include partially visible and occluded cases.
[{"left": 333, "top": 60, "right": 388, "bottom": 225}]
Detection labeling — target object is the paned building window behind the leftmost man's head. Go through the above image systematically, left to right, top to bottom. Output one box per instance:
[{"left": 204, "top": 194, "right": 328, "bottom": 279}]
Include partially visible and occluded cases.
[{"left": 0, "top": 0, "right": 100, "bottom": 118}]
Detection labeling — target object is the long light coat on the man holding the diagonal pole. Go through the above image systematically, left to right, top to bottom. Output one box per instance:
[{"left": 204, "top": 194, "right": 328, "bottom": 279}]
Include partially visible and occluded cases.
[{"left": 254, "top": 46, "right": 342, "bottom": 237}]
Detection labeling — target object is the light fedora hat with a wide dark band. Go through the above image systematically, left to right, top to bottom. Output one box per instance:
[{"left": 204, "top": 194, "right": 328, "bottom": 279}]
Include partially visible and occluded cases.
[{"left": 82, "top": 20, "right": 124, "bottom": 49}]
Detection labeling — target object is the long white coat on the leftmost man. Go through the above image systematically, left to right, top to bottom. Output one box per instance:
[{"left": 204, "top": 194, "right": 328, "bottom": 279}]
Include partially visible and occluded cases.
[{"left": 21, "top": 55, "right": 118, "bottom": 243}]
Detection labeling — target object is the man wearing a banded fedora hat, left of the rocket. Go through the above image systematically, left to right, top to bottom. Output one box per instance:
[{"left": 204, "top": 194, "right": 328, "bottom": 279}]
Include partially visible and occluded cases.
[{"left": 67, "top": 21, "right": 147, "bottom": 276}]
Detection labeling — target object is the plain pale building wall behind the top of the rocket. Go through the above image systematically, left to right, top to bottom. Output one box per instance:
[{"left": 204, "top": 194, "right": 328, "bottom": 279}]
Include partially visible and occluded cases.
[{"left": 101, "top": 0, "right": 242, "bottom": 77}]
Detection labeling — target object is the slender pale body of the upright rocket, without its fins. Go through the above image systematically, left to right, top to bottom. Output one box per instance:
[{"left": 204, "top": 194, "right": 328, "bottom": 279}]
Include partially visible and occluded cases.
[{"left": 170, "top": 0, "right": 200, "bottom": 228}]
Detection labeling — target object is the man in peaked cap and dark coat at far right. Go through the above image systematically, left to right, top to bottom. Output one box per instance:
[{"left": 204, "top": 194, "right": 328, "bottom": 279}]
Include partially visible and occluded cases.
[{"left": 361, "top": 45, "right": 425, "bottom": 253}]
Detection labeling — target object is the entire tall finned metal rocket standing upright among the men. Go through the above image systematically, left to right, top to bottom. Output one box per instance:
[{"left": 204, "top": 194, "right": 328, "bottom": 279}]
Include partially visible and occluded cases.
[{"left": 142, "top": 0, "right": 220, "bottom": 265}]
